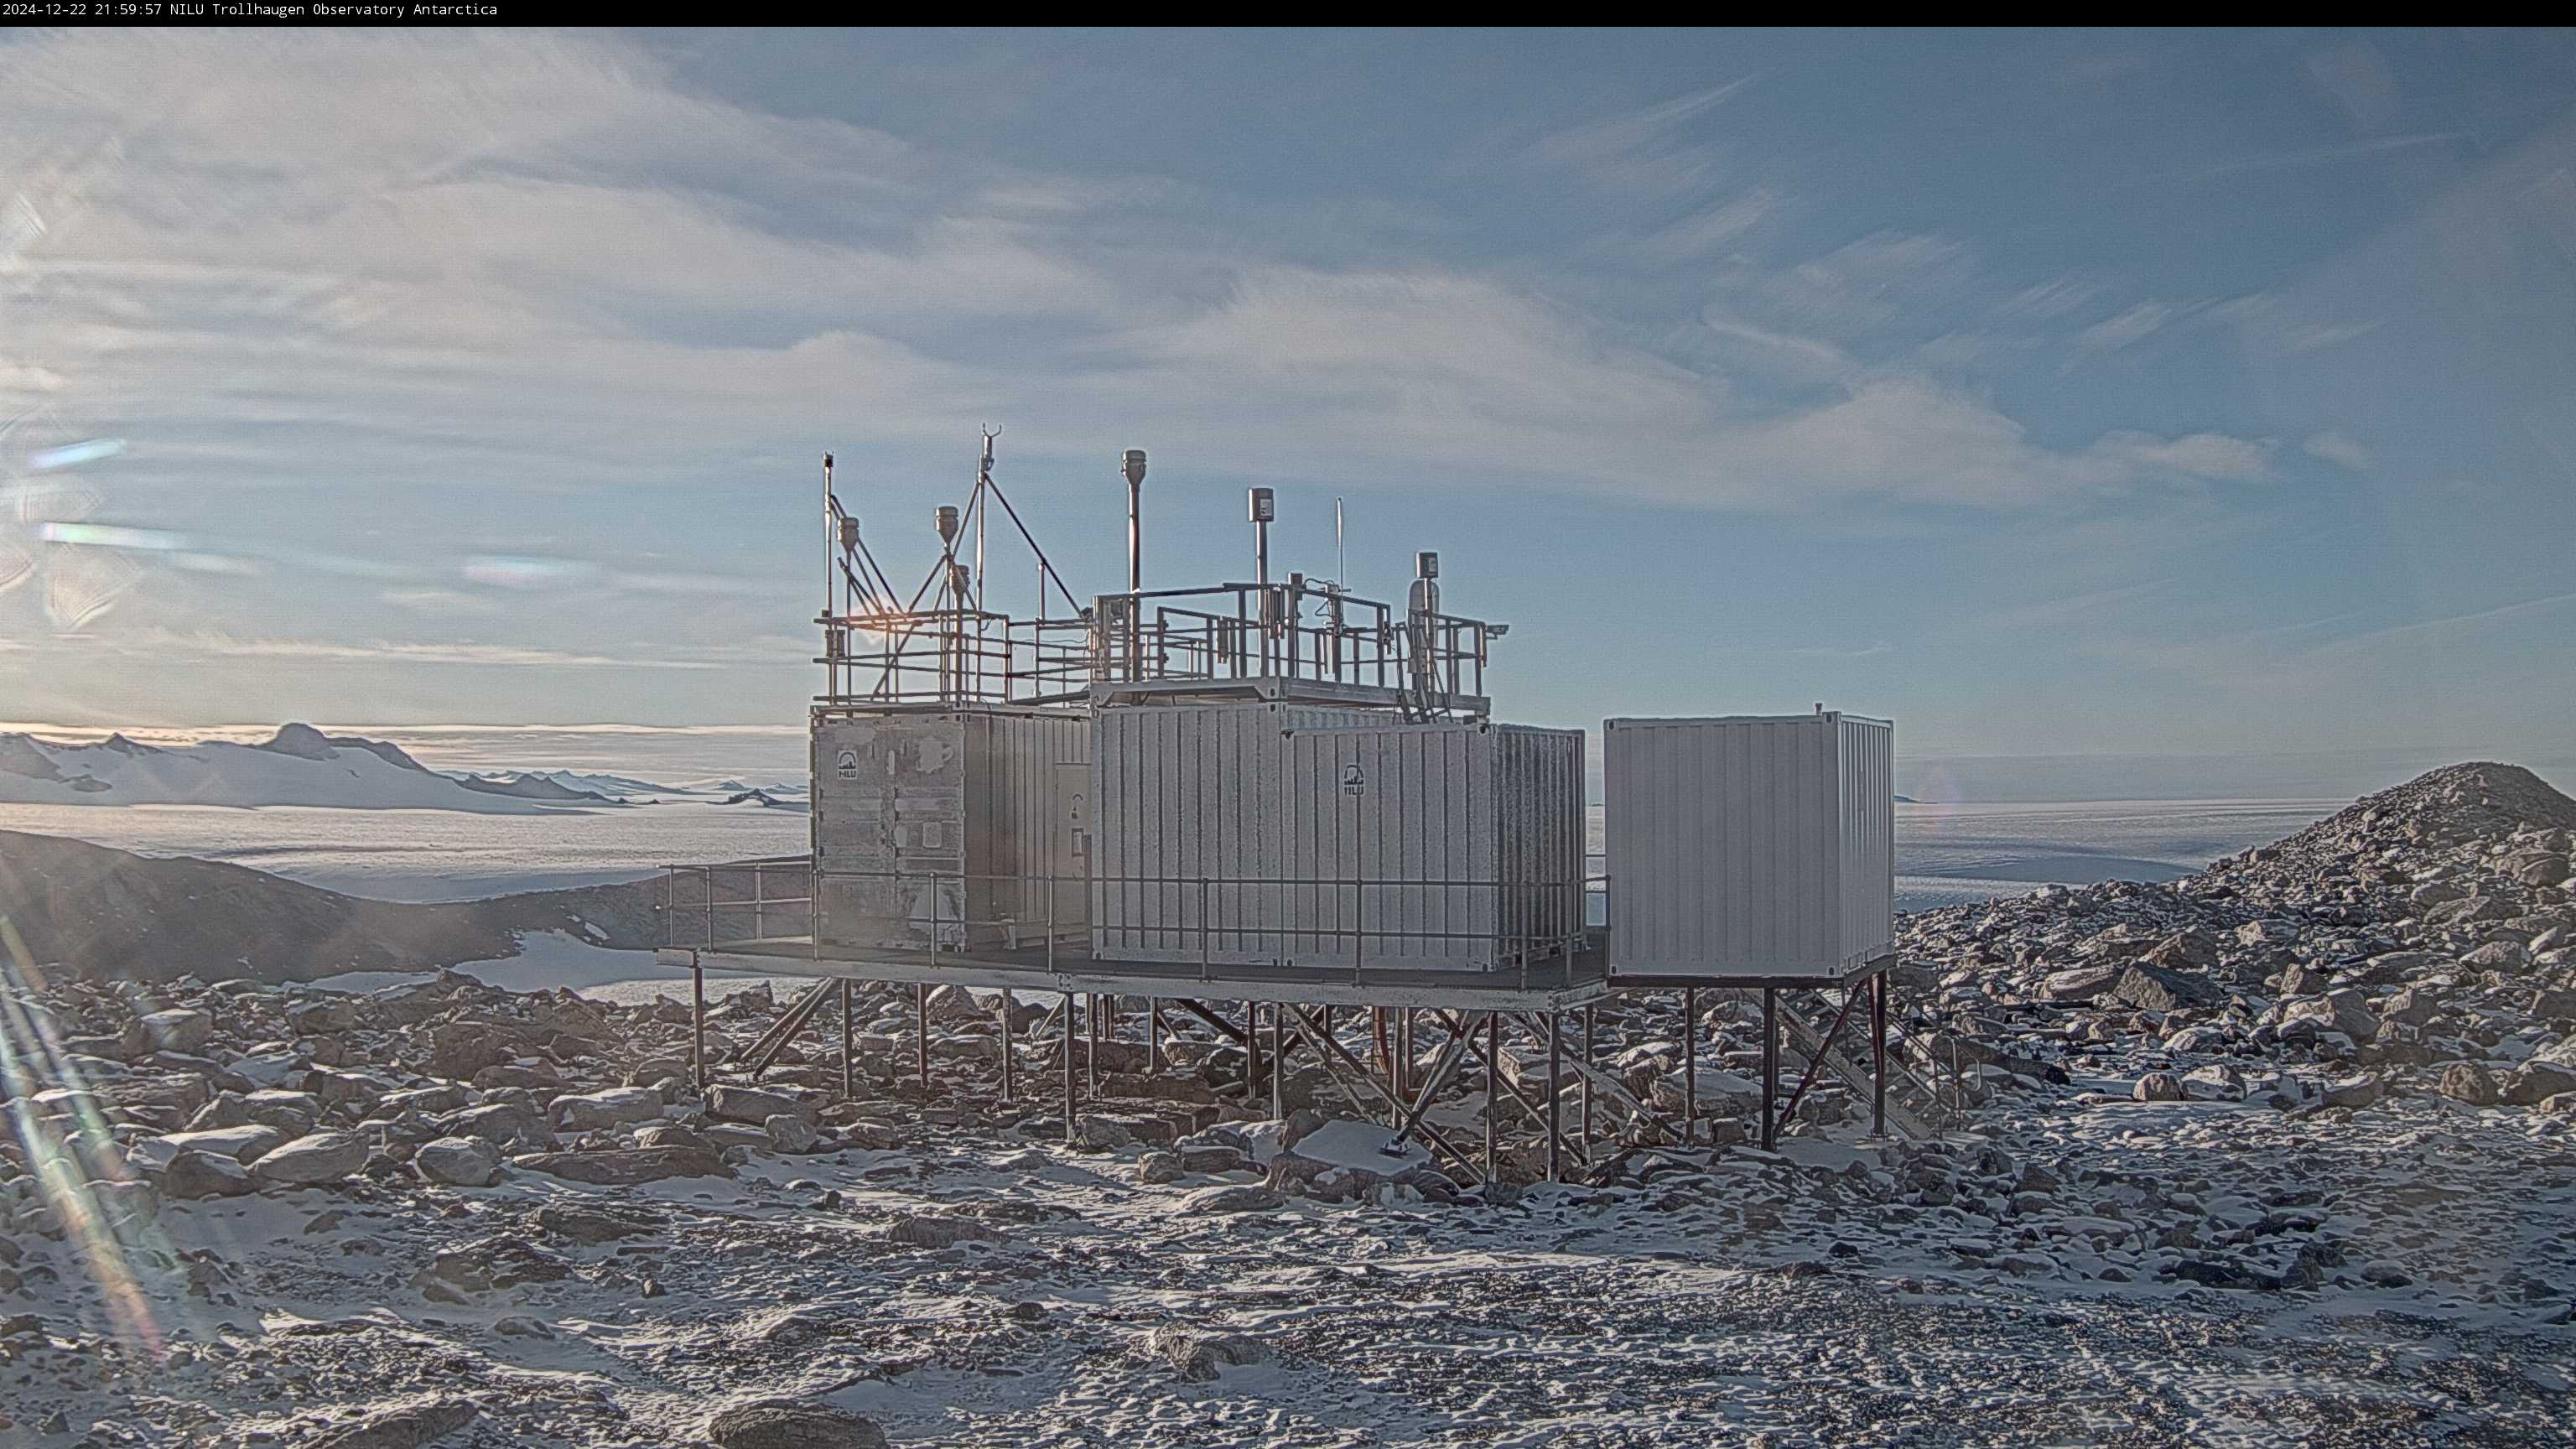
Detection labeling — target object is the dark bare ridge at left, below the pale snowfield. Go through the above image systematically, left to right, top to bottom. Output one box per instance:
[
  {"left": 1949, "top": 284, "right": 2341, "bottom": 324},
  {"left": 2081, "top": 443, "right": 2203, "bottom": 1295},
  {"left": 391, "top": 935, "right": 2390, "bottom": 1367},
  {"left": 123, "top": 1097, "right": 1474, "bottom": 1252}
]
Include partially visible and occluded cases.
[{"left": 0, "top": 830, "right": 662, "bottom": 982}]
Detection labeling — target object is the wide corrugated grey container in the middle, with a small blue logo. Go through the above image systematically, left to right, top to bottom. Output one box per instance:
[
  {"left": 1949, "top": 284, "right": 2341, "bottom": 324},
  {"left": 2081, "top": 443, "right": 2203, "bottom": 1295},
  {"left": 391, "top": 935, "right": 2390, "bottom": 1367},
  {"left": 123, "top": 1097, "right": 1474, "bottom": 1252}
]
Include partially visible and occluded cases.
[{"left": 1093, "top": 704, "right": 1584, "bottom": 969}]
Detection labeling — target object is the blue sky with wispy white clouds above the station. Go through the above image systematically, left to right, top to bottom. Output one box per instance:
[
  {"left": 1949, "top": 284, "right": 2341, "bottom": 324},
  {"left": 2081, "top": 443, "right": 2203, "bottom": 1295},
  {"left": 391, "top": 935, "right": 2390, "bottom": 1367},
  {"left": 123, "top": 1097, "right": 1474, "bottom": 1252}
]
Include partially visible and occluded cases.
[{"left": 0, "top": 31, "right": 2576, "bottom": 758}]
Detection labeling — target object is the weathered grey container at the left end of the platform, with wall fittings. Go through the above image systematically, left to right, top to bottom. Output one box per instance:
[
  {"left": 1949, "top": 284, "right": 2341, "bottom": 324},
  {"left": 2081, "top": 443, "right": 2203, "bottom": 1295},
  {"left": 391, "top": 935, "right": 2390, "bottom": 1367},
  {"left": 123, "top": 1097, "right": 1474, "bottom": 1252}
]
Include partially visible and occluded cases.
[{"left": 814, "top": 709, "right": 1093, "bottom": 946}]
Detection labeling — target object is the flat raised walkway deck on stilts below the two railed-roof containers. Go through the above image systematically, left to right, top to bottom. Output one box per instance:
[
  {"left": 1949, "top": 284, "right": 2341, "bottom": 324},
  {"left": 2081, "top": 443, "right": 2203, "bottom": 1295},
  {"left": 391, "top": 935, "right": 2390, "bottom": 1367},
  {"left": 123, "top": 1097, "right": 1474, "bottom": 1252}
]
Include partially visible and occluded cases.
[{"left": 659, "top": 936, "right": 1613, "bottom": 1010}]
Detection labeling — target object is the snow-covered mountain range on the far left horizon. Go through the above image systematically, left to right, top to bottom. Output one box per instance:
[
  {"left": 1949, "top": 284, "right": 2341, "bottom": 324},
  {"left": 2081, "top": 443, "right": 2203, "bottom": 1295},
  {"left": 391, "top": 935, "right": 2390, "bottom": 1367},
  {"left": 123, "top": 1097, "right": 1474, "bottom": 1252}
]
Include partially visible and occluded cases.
[{"left": 0, "top": 724, "right": 598, "bottom": 815}]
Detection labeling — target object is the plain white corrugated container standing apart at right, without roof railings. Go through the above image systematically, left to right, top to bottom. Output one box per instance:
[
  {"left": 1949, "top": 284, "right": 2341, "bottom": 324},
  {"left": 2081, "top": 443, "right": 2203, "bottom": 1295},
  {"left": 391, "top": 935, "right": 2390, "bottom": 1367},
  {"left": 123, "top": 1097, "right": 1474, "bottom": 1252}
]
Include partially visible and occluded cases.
[{"left": 1602, "top": 714, "right": 1896, "bottom": 977}]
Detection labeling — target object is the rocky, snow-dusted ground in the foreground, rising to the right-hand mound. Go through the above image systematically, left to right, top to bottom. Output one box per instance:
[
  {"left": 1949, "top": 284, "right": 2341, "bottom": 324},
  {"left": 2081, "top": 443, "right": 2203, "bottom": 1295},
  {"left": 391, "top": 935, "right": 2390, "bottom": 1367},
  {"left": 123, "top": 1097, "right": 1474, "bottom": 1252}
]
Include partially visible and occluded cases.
[{"left": 0, "top": 766, "right": 2576, "bottom": 1449}]
